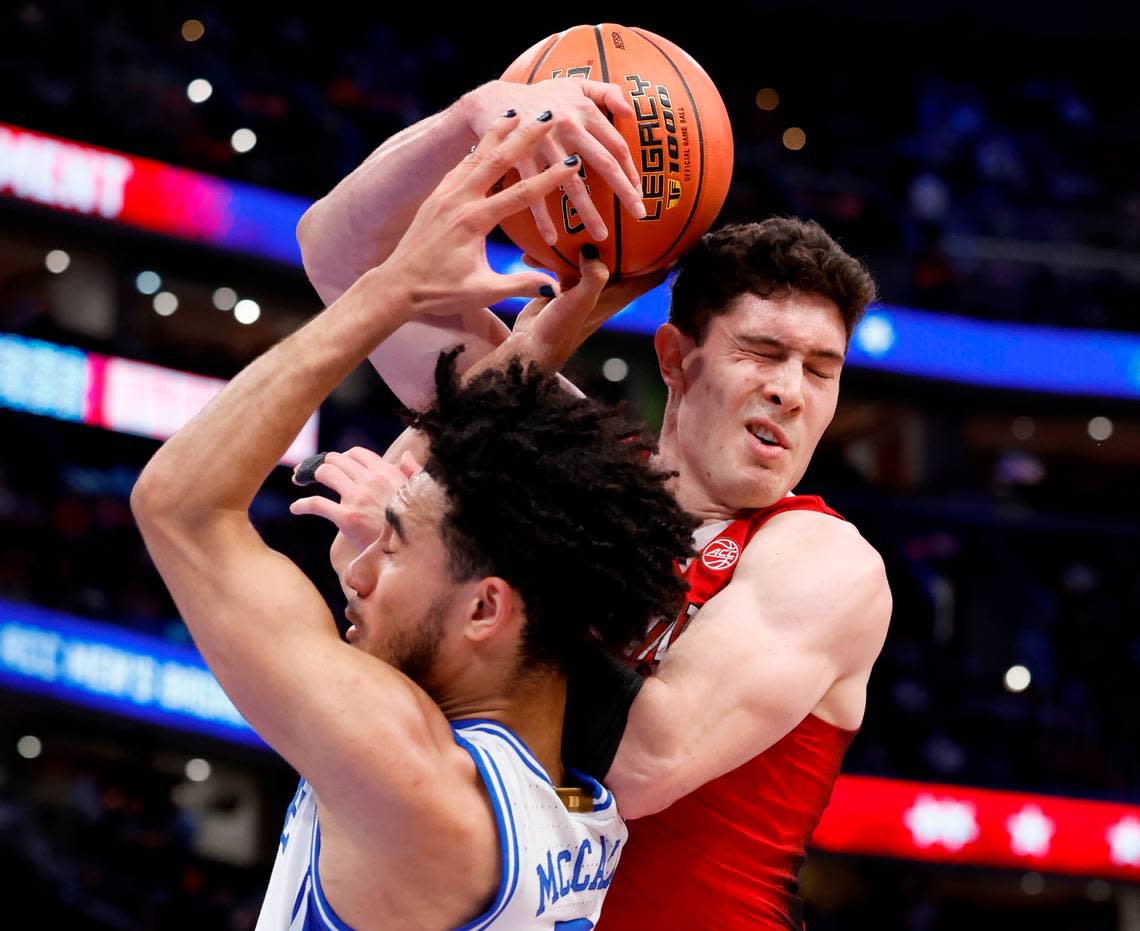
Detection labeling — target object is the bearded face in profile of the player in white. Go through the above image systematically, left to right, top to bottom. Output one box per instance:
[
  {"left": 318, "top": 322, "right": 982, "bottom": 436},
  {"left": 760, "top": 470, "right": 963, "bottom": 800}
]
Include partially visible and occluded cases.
[{"left": 344, "top": 473, "right": 461, "bottom": 692}]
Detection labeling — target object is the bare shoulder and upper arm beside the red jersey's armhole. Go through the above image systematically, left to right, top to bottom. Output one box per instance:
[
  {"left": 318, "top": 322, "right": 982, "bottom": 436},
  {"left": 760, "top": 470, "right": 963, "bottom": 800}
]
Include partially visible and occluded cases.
[{"left": 606, "top": 512, "right": 890, "bottom": 818}]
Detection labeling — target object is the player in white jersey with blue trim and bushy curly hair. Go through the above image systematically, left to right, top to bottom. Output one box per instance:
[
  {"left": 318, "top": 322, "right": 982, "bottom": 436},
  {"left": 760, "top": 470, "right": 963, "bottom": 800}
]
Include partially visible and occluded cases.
[{"left": 131, "top": 114, "right": 693, "bottom": 931}]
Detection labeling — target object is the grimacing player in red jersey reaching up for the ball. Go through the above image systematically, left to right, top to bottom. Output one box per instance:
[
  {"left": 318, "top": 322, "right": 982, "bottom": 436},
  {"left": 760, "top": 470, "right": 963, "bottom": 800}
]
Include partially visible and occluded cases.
[{"left": 299, "top": 82, "right": 890, "bottom": 931}]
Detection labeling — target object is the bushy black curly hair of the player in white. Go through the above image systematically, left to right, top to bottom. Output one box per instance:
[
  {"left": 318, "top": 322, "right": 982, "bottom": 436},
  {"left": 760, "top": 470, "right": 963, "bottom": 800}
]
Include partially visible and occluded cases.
[{"left": 406, "top": 348, "right": 698, "bottom": 670}]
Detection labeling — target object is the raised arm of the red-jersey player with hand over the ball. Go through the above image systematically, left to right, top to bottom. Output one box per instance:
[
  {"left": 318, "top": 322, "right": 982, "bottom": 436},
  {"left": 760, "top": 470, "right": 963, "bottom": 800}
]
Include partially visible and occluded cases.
[{"left": 298, "top": 79, "right": 644, "bottom": 409}]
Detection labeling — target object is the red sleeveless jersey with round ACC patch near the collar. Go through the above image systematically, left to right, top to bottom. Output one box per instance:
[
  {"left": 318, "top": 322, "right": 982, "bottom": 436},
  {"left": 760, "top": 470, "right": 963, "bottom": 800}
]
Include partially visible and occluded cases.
[{"left": 597, "top": 495, "right": 854, "bottom": 931}]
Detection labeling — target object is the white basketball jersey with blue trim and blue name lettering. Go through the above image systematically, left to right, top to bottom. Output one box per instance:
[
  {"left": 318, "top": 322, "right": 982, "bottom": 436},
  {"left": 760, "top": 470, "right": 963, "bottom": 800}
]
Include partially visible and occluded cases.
[{"left": 257, "top": 719, "right": 627, "bottom": 931}]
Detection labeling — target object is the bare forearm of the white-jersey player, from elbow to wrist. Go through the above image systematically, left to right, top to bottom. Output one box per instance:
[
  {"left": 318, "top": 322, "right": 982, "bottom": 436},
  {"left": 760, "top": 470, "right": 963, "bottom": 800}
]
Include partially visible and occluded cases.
[{"left": 135, "top": 269, "right": 409, "bottom": 522}]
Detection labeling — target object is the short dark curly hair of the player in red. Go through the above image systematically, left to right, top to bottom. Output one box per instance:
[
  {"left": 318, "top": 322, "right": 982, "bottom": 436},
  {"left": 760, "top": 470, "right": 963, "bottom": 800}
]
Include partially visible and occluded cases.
[{"left": 669, "top": 217, "right": 876, "bottom": 343}]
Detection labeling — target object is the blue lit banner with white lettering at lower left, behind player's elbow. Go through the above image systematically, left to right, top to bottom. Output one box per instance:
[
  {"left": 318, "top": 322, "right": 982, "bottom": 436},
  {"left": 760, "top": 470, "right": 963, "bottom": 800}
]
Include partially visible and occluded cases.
[{"left": 0, "top": 601, "right": 266, "bottom": 748}]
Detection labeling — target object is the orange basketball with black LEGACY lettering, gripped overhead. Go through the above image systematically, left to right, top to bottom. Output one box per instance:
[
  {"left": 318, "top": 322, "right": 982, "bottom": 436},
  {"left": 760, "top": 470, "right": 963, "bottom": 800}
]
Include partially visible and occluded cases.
[{"left": 500, "top": 23, "right": 733, "bottom": 275}]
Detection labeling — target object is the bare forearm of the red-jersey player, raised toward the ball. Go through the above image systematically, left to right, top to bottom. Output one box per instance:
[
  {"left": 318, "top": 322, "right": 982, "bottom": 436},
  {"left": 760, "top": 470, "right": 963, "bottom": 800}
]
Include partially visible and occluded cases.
[{"left": 296, "top": 99, "right": 477, "bottom": 303}]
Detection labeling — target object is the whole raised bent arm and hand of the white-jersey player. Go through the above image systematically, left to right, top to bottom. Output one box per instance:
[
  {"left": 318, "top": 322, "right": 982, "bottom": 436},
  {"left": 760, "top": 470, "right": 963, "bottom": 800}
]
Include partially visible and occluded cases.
[{"left": 131, "top": 114, "right": 576, "bottom": 810}]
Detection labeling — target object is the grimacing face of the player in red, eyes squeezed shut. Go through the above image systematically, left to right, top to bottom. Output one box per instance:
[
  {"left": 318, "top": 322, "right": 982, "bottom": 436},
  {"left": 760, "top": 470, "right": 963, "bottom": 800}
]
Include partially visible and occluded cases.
[{"left": 677, "top": 293, "right": 847, "bottom": 511}]
